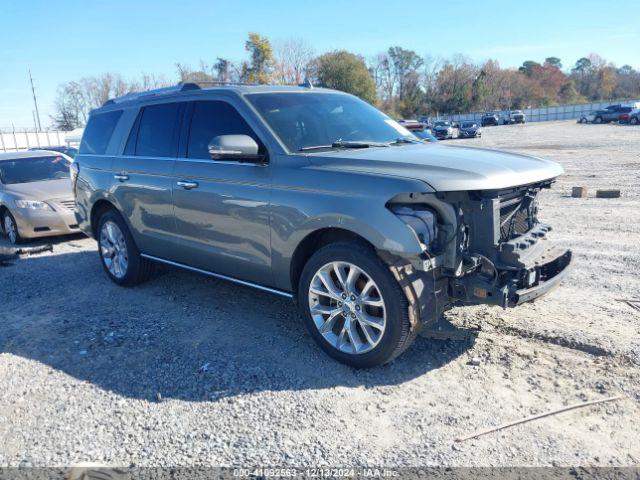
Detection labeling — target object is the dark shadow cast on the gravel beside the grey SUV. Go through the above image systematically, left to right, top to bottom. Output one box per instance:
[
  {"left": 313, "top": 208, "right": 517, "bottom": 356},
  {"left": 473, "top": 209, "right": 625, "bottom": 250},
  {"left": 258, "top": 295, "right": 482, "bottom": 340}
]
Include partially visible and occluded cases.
[{"left": 0, "top": 251, "right": 475, "bottom": 401}]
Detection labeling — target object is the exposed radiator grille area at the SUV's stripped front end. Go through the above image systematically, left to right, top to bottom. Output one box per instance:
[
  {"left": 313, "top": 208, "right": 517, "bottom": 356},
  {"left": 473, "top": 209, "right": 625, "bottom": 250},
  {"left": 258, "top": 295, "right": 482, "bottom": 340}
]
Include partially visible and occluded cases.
[{"left": 499, "top": 189, "right": 537, "bottom": 242}]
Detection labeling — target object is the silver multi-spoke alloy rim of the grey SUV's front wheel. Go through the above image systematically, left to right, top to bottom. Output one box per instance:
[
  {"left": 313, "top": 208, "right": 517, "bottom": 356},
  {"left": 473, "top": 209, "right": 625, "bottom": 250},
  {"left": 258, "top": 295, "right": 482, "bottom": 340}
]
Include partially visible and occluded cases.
[{"left": 308, "top": 262, "right": 387, "bottom": 354}]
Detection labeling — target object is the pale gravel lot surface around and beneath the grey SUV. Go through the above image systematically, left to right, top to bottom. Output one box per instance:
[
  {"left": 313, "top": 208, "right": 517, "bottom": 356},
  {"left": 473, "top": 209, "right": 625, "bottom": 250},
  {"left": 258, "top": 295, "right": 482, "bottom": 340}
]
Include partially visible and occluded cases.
[{"left": 0, "top": 122, "right": 640, "bottom": 467}]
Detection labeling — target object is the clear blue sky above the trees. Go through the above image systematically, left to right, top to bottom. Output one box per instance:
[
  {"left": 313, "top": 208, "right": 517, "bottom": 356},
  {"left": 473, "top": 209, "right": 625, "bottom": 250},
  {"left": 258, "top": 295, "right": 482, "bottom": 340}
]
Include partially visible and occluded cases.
[{"left": 0, "top": 0, "right": 640, "bottom": 129}]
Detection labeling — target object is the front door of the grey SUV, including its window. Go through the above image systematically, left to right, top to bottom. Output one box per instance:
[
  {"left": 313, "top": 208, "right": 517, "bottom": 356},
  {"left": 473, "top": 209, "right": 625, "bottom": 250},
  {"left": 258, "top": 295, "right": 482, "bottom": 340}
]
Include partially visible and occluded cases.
[{"left": 173, "top": 99, "right": 272, "bottom": 285}]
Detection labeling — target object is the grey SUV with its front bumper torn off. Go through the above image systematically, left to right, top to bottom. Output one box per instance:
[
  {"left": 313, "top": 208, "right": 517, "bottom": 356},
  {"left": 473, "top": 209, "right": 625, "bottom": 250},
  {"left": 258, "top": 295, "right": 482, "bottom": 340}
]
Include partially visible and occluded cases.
[{"left": 72, "top": 83, "right": 571, "bottom": 367}]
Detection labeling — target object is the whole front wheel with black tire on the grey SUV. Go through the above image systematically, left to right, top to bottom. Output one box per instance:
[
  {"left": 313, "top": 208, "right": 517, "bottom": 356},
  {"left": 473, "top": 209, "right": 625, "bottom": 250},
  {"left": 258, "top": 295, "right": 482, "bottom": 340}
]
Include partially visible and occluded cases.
[{"left": 298, "top": 242, "right": 415, "bottom": 368}]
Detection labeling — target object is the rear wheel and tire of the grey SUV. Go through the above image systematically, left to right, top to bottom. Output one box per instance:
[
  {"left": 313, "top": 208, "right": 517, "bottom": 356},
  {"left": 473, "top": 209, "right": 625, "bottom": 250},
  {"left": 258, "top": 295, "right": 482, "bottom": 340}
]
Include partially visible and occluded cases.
[{"left": 98, "top": 210, "right": 153, "bottom": 287}]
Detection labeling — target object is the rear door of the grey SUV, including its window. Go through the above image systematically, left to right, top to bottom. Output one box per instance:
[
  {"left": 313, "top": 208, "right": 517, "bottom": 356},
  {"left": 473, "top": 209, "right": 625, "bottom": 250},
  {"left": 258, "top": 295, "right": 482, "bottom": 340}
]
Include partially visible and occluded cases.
[{"left": 113, "top": 102, "right": 185, "bottom": 258}]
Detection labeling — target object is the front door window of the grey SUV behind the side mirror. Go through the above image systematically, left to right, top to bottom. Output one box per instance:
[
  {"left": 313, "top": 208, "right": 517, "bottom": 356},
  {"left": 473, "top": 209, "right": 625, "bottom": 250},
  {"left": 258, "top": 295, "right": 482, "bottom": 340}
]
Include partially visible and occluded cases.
[{"left": 187, "top": 100, "right": 264, "bottom": 159}]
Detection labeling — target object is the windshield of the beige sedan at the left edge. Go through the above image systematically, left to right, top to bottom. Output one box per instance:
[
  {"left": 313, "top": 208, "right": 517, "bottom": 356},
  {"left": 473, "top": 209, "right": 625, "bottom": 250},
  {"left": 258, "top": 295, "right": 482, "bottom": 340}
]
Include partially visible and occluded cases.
[{"left": 0, "top": 156, "right": 70, "bottom": 184}]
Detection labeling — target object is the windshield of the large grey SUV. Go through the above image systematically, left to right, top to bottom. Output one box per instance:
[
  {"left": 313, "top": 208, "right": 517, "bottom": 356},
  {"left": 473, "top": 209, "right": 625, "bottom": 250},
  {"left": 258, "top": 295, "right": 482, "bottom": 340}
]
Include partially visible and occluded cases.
[{"left": 246, "top": 92, "right": 414, "bottom": 152}]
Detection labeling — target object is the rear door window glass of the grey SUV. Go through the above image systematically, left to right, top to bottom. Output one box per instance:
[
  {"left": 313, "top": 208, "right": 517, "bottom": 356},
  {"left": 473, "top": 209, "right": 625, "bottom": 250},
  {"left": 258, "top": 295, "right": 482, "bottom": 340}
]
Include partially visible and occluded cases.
[{"left": 132, "top": 102, "right": 182, "bottom": 157}]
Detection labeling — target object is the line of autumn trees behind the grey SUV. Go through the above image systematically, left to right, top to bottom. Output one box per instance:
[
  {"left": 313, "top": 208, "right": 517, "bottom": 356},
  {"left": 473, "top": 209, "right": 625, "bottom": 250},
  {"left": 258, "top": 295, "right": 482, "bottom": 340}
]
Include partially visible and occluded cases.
[{"left": 52, "top": 33, "right": 640, "bottom": 130}]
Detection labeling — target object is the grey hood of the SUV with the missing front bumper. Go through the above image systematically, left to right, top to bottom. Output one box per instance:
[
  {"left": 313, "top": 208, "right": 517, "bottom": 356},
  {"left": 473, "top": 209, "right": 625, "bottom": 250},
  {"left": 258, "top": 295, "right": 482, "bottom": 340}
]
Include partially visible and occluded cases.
[{"left": 309, "top": 143, "right": 563, "bottom": 192}]
